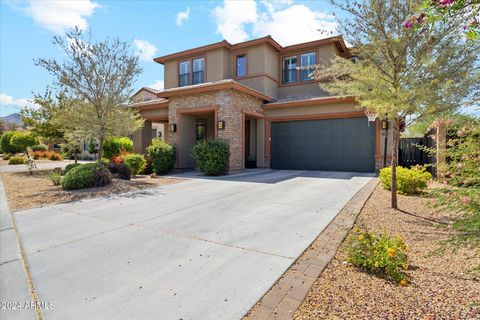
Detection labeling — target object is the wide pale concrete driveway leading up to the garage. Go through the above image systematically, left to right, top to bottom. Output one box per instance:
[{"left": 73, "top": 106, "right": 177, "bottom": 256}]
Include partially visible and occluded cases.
[{"left": 10, "top": 170, "right": 371, "bottom": 320}]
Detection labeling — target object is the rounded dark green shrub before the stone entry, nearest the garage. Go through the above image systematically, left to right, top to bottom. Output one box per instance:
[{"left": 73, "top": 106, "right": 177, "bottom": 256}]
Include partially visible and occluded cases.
[{"left": 192, "top": 139, "right": 230, "bottom": 176}]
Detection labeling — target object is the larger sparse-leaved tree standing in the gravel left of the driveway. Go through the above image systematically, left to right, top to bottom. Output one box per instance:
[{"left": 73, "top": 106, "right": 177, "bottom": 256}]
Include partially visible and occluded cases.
[{"left": 35, "top": 28, "right": 143, "bottom": 158}]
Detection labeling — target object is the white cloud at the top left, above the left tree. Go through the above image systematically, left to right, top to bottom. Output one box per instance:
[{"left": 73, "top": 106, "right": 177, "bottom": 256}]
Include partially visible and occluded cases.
[{"left": 23, "top": 0, "right": 100, "bottom": 33}]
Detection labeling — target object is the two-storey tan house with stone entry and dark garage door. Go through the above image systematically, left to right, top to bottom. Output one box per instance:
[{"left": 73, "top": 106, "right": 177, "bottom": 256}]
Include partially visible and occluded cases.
[{"left": 133, "top": 36, "right": 391, "bottom": 172}]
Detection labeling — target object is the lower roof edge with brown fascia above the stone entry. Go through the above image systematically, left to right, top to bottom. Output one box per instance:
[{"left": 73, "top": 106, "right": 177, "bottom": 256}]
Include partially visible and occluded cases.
[{"left": 157, "top": 79, "right": 275, "bottom": 101}]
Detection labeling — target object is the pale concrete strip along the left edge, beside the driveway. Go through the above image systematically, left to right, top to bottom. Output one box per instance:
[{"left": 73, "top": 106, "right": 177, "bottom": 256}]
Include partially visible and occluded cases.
[{"left": 0, "top": 177, "right": 45, "bottom": 320}]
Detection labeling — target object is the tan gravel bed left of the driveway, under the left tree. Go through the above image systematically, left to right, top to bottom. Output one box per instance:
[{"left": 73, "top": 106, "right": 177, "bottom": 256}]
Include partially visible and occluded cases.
[{"left": 1, "top": 171, "right": 186, "bottom": 211}]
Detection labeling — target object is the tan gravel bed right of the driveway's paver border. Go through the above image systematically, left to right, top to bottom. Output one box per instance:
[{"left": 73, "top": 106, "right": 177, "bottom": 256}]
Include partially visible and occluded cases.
[{"left": 293, "top": 185, "right": 480, "bottom": 320}]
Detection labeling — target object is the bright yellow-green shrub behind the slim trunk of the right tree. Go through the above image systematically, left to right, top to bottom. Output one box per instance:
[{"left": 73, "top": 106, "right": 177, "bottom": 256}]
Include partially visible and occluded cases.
[{"left": 380, "top": 166, "right": 432, "bottom": 195}]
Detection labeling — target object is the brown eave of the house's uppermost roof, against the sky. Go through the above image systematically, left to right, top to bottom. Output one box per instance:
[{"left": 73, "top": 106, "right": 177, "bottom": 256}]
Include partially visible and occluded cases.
[{"left": 153, "top": 36, "right": 349, "bottom": 64}]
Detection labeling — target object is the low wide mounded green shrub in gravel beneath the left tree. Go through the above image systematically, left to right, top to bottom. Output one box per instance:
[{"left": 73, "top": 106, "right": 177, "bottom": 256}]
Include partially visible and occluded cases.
[{"left": 62, "top": 163, "right": 112, "bottom": 190}]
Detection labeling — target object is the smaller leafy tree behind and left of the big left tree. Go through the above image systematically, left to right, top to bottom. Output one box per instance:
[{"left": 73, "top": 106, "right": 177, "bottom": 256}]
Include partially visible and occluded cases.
[{"left": 20, "top": 88, "right": 68, "bottom": 144}]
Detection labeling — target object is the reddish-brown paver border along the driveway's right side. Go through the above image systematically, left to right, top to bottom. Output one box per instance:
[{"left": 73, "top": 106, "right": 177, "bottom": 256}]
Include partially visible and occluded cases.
[{"left": 243, "top": 178, "right": 379, "bottom": 320}]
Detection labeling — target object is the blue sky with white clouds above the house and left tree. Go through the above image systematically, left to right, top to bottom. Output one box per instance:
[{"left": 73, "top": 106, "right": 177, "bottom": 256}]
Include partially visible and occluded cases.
[{"left": 0, "top": 0, "right": 342, "bottom": 116}]
